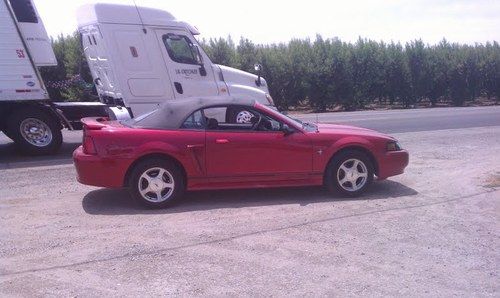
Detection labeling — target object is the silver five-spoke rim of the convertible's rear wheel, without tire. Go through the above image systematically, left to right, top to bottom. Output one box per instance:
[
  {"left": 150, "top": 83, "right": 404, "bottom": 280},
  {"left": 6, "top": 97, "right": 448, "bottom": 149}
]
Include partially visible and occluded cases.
[{"left": 138, "top": 167, "right": 175, "bottom": 203}]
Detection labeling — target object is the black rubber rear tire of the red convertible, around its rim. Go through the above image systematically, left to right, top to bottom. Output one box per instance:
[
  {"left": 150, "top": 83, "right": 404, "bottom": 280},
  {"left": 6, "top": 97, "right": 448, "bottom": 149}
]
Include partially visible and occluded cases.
[{"left": 129, "top": 158, "right": 186, "bottom": 209}]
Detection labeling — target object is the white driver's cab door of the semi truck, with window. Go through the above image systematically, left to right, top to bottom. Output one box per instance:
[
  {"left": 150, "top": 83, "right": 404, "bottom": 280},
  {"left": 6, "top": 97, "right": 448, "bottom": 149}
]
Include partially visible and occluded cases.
[{"left": 156, "top": 30, "right": 218, "bottom": 98}]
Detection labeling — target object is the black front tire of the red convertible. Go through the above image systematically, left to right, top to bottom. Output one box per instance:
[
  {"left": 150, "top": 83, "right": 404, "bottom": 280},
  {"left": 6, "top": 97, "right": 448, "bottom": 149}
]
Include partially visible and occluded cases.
[{"left": 325, "top": 150, "right": 374, "bottom": 197}]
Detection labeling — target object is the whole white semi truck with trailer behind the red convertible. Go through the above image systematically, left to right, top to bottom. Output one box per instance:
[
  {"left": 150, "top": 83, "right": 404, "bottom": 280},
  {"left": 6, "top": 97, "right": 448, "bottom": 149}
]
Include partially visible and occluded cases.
[{"left": 0, "top": 0, "right": 274, "bottom": 155}]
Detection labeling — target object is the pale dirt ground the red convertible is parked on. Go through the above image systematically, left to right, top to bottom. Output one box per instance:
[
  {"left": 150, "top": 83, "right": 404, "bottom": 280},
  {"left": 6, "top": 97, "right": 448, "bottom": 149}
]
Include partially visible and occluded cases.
[{"left": 0, "top": 127, "right": 500, "bottom": 297}]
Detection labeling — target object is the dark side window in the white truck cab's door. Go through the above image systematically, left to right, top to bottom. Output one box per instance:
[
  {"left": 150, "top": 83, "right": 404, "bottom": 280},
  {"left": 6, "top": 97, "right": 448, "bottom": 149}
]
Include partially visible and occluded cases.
[{"left": 163, "top": 34, "right": 198, "bottom": 64}]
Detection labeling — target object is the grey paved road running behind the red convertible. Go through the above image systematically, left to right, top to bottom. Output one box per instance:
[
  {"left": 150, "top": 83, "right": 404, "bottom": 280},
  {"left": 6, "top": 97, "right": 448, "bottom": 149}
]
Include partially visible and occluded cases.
[{"left": 0, "top": 106, "right": 500, "bottom": 169}]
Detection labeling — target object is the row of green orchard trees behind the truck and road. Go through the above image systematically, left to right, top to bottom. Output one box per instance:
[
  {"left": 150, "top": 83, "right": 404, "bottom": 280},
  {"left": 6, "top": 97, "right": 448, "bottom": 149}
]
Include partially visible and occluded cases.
[{"left": 41, "top": 33, "right": 500, "bottom": 111}]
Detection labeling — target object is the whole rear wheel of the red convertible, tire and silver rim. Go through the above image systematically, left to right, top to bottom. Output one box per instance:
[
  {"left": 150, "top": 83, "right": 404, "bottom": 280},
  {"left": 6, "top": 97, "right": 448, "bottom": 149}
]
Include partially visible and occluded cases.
[{"left": 130, "top": 159, "right": 185, "bottom": 208}]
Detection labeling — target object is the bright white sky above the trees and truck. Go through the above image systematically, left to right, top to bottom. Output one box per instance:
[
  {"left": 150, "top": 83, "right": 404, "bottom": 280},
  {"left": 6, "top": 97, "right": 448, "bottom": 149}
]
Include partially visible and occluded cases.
[{"left": 34, "top": 0, "right": 500, "bottom": 44}]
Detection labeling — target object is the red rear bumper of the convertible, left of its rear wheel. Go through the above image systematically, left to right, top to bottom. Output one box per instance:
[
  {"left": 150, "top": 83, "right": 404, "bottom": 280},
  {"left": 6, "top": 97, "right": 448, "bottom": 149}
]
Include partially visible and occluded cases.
[{"left": 73, "top": 146, "right": 129, "bottom": 188}]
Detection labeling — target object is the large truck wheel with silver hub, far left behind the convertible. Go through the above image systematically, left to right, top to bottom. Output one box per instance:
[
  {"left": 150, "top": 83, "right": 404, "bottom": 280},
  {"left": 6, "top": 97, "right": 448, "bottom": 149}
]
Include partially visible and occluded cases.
[{"left": 7, "top": 109, "right": 62, "bottom": 155}]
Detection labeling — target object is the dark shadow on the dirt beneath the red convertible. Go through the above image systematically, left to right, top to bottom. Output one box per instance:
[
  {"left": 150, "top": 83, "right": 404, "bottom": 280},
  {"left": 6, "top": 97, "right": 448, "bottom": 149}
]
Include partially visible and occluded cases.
[{"left": 82, "top": 180, "right": 418, "bottom": 215}]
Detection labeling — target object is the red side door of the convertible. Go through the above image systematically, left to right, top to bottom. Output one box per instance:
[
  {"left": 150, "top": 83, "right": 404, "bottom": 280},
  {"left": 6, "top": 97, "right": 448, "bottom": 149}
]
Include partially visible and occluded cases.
[{"left": 206, "top": 106, "right": 312, "bottom": 182}]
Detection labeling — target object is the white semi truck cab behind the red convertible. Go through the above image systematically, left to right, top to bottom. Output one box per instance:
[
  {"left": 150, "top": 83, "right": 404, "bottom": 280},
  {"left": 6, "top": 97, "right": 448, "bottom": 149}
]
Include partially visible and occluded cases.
[{"left": 77, "top": 4, "right": 273, "bottom": 118}]
